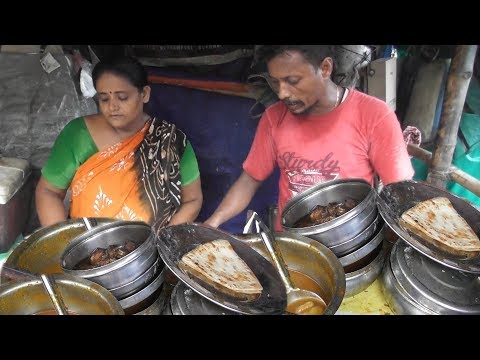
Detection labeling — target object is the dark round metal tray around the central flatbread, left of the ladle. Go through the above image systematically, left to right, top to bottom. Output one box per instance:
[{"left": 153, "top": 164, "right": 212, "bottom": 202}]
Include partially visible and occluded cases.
[{"left": 157, "top": 223, "right": 287, "bottom": 315}]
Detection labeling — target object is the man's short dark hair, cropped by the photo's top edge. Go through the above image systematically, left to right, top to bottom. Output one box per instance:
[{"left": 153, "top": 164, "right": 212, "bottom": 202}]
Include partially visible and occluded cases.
[{"left": 255, "top": 45, "right": 335, "bottom": 67}]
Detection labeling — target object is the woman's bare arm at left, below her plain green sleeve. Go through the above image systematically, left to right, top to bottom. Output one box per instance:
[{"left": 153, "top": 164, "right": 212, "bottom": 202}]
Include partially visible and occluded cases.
[{"left": 35, "top": 176, "right": 67, "bottom": 227}]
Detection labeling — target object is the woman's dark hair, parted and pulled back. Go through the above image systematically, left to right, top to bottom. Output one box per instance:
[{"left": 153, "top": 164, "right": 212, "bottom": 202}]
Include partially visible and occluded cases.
[{"left": 92, "top": 55, "right": 148, "bottom": 91}]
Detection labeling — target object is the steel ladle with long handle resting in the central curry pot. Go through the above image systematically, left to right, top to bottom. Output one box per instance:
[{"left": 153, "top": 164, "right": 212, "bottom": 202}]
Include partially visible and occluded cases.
[{"left": 245, "top": 211, "right": 327, "bottom": 311}]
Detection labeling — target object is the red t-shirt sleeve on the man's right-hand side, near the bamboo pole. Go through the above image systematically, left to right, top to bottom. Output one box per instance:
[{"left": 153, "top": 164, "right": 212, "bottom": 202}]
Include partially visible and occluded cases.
[{"left": 369, "top": 111, "right": 414, "bottom": 185}]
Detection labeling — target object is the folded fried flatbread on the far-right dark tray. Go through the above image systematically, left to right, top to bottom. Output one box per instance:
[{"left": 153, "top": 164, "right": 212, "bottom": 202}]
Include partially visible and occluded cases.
[{"left": 400, "top": 197, "right": 480, "bottom": 258}]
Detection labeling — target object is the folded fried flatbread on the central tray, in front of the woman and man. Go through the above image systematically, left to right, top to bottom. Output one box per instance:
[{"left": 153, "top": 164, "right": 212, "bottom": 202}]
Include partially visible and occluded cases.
[{"left": 179, "top": 239, "right": 263, "bottom": 300}]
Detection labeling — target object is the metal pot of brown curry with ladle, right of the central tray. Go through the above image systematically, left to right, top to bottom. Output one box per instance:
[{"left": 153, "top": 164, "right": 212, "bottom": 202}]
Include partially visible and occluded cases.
[{"left": 236, "top": 232, "right": 345, "bottom": 315}]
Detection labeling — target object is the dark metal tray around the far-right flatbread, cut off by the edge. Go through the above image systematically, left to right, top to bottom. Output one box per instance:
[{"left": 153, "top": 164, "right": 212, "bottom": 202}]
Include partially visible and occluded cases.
[{"left": 377, "top": 180, "right": 480, "bottom": 274}]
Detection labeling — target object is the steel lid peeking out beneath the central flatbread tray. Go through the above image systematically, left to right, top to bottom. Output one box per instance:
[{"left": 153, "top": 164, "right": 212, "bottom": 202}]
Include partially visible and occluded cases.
[{"left": 170, "top": 282, "right": 238, "bottom": 315}]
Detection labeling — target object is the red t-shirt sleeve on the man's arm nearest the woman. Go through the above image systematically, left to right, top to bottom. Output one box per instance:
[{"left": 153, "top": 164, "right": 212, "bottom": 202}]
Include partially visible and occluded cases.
[{"left": 243, "top": 111, "right": 276, "bottom": 181}]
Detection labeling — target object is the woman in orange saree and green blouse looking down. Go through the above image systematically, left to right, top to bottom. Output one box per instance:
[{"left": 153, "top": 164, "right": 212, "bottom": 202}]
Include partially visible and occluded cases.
[{"left": 36, "top": 57, "right": 202, "bottom": 229}]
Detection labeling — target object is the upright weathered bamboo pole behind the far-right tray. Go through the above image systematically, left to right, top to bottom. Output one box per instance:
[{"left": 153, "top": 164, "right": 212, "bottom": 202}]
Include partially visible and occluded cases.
[{"left": 427, "top": 45, "right": 477, "bottom": 188}]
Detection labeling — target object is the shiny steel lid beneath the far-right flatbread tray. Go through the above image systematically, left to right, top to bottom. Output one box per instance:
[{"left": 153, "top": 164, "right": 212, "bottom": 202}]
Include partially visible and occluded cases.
[{"left": 390, "top": 240, "right": 480, "bottom": 315}]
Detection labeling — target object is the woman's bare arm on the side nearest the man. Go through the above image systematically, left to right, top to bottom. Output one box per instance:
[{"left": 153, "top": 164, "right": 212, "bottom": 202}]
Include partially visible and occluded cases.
[{"left": 168, "top": 176, "right": 203, "bottom": 225}]
